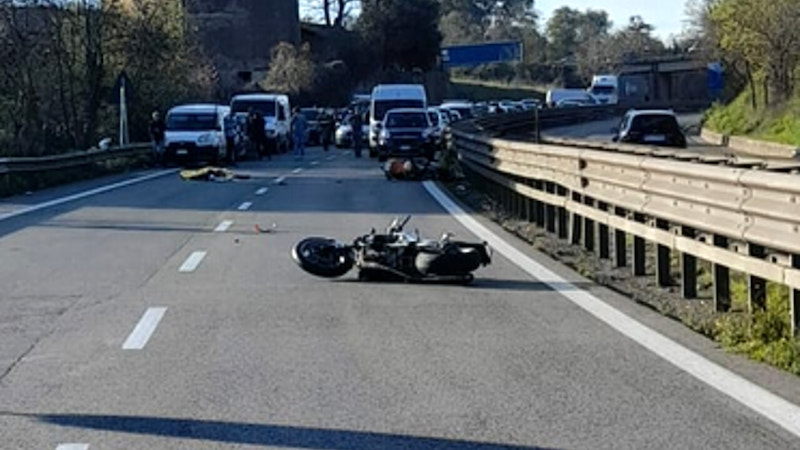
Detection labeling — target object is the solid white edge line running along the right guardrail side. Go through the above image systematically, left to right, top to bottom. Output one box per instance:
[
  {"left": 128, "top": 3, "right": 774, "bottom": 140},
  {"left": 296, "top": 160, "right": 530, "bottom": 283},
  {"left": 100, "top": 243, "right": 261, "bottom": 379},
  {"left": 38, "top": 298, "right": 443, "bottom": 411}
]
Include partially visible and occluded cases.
[{"left": 423, "top": 181, "right": 800, "bottom": 437}]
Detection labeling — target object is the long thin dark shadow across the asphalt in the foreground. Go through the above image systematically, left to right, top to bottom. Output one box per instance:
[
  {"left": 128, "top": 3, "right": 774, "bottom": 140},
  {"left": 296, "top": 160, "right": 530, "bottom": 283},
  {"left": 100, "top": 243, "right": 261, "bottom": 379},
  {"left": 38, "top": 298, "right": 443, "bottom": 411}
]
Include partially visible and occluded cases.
[{"left": 33, "top": 414, "right": 564, "bottom": 450}]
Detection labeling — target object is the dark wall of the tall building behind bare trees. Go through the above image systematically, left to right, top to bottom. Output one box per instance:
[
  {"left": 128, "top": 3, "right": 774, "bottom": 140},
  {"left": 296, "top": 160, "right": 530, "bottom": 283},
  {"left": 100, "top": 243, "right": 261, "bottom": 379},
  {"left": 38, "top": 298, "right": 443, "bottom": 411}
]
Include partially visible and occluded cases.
[{"left": 183, "top": 0, "right": 300, "bottom": 93}]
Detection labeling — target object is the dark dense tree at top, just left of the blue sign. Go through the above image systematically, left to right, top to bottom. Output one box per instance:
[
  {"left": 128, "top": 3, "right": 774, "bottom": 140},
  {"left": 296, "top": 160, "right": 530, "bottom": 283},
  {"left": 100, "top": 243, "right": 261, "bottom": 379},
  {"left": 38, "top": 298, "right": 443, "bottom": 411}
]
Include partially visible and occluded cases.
[{"left": 357, "top": 0, "right": 442, "bottom": 70}]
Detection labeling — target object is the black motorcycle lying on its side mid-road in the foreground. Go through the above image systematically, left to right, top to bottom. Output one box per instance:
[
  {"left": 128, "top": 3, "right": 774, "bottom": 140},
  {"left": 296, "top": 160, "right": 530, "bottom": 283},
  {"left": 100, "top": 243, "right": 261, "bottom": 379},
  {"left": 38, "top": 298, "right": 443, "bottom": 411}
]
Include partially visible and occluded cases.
[{"left": 292, "top": 216, "right": 491, "bottom": 284}]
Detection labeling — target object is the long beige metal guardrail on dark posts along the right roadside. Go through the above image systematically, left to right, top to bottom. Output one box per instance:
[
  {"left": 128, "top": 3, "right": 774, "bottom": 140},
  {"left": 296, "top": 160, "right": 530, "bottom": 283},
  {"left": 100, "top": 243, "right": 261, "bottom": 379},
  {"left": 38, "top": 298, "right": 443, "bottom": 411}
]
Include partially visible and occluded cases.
[{"left": 452, "top": 129, "right": 800, "bottom": 332}]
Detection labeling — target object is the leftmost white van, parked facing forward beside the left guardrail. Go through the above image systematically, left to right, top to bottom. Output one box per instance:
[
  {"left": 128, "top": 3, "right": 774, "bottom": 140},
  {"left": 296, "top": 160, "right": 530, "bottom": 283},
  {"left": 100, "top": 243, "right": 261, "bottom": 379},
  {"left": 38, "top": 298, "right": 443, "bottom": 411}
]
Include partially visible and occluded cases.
[{"left": 164, "top": 104, "right": 230, "bottom": 164}]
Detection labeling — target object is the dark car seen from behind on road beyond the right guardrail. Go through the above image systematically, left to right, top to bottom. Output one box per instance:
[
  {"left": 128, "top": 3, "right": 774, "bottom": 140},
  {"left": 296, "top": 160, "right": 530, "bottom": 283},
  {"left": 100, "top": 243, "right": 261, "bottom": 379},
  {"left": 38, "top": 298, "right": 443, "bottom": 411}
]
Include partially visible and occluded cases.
[{"left": 612, "top": 110, "right": 687, "bottom": 148}]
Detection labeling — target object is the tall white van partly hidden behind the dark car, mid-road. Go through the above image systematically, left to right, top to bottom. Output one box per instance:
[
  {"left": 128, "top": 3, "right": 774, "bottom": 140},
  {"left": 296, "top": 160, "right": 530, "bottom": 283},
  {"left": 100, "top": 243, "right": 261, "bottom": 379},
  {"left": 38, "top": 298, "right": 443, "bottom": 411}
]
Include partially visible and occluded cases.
[{"left": 369, "top": 84, "right": 428, "bottom": 157}]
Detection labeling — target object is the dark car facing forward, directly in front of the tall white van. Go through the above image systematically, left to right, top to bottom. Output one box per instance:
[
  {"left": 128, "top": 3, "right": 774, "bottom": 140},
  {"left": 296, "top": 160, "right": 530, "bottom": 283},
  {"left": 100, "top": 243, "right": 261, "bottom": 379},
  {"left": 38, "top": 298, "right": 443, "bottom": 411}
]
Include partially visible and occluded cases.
[{"left": 378, "top": 108, "right": 436, "bottom": 160}]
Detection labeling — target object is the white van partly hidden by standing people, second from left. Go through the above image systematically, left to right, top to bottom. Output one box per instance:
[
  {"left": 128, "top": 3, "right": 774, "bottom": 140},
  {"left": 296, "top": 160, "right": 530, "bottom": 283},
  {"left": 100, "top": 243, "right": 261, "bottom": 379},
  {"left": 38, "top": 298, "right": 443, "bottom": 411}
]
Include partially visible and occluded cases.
[{"left": 231, "top": 94, "right": 292, "bottom": 153}]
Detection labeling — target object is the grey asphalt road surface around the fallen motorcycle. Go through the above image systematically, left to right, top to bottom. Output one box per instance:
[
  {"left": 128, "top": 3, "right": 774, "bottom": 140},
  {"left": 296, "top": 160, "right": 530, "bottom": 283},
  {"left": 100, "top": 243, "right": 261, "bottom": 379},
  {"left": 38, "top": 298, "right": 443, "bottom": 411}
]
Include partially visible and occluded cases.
[{"left": 0, "top": 149, "right": 800, "bottom": 450}]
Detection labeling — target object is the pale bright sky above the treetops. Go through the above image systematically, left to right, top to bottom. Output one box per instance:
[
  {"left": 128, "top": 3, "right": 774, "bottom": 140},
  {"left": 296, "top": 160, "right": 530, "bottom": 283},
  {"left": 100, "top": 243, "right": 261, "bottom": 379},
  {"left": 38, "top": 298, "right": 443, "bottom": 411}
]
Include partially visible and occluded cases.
[{"left": 300, "top": 0, "right": 686, "bottom": 40}]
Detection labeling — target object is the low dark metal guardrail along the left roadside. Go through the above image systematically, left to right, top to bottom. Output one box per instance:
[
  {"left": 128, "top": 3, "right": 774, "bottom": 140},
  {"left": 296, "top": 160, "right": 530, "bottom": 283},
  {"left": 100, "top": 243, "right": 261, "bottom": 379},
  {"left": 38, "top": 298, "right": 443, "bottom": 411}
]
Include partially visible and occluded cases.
[{"left": 0, "top": 144, "right": 152, "bottom": 175}]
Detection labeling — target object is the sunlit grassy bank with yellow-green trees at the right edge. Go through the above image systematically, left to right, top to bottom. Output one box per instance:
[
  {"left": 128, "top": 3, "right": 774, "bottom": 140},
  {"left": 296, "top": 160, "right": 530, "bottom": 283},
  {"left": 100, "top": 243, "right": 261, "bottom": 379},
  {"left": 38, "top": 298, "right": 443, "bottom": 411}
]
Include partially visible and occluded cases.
[{"left": 693, "top": 0, "right": 800, "bottom": 145}]
